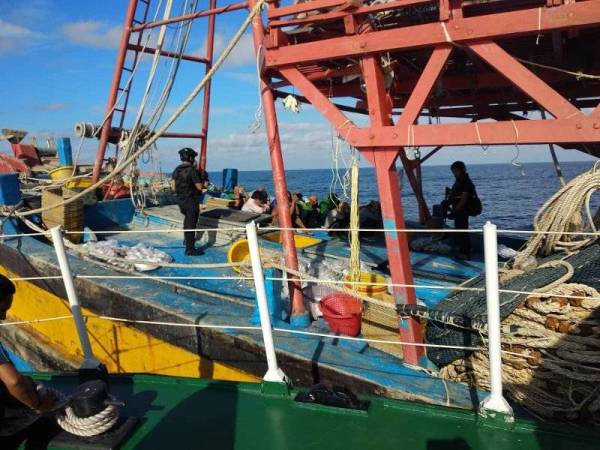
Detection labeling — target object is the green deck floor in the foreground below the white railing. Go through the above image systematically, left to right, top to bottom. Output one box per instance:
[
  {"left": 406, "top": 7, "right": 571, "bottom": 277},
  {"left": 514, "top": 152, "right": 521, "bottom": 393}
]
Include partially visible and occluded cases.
[{"left": 2, "top": 375, "right": 600, "bottom": 450}]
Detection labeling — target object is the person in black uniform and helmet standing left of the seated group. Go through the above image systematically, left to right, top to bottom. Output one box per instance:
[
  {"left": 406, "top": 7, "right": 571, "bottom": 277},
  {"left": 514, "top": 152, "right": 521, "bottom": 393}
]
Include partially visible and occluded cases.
[{"left": 171, "top": 147, "right": 208, "bottom": 256}]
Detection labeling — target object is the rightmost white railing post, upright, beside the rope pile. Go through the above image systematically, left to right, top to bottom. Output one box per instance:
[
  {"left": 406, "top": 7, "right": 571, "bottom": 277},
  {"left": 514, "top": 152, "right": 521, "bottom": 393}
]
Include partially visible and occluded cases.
[{"left": 479, "top": 222, "right": 513, "bottom": 421}]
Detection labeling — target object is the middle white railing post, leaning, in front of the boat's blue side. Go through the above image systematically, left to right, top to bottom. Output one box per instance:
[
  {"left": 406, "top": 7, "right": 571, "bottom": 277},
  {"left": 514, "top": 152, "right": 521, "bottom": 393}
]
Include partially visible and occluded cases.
[{"left": 246, "top": 221, "right": 287, "bottom": 383}]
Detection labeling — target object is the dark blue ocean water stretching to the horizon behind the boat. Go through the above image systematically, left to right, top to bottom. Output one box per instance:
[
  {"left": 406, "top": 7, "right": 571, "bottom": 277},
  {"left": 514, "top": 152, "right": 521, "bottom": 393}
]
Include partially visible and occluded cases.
[{"left": 210, "top": 162, "right": 599, "bottom": 230}]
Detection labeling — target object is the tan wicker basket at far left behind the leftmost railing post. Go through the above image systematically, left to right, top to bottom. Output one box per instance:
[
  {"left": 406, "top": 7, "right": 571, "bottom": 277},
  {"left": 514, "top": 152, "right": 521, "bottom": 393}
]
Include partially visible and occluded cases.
[{"left": 42, "top": 188, "right": 83, "bottom": 244}]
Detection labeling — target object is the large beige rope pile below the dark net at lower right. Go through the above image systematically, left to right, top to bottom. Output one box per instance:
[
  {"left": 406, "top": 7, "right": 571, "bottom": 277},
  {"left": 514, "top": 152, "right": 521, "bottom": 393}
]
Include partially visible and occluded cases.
[{"left": 440, "top": 283, "right": 600, "bottom": 424}]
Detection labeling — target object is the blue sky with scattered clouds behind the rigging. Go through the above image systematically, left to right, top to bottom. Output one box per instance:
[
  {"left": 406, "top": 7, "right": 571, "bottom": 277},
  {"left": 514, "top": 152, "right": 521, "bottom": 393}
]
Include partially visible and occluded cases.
[{"left": 0, "top": 0, "right": 585, "bottom": 170}]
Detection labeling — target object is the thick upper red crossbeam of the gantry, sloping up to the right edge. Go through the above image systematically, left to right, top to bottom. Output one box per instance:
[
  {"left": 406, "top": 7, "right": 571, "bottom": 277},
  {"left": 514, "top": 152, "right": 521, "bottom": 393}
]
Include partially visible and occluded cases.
[{"left": 266, "top": 0, "right": 600, "bottom": 68}]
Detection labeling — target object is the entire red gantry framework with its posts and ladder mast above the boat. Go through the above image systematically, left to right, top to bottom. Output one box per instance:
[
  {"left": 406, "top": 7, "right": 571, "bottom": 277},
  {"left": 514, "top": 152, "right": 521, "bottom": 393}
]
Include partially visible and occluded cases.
[{"left": 97, "top": 0, "right": 600, "bottom": 364}]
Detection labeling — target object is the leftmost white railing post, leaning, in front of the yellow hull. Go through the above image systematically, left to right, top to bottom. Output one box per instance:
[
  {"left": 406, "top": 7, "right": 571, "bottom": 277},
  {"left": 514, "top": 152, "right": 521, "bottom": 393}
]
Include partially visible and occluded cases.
[{"left": 50, "top": 226, "right": 100, "bottom": 369}]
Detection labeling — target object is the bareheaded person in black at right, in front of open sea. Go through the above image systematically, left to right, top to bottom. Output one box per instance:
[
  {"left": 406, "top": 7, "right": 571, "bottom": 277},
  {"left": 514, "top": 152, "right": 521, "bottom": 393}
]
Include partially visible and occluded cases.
[{"left": 446, "top": 161, "right": 478, "bottom": 259}]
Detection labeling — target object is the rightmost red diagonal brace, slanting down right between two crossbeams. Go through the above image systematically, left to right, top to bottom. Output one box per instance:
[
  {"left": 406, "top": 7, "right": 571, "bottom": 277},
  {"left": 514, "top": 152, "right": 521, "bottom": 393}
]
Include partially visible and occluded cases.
[{"left": 469, "top": 42, "right": 579, "bottom": 118}]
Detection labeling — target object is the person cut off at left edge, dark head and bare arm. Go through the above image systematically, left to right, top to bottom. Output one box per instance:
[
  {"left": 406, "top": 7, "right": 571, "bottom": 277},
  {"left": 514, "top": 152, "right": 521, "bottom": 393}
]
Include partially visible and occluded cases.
[{"left": 0, "top": 275, "right": 56, "bottom": 416}]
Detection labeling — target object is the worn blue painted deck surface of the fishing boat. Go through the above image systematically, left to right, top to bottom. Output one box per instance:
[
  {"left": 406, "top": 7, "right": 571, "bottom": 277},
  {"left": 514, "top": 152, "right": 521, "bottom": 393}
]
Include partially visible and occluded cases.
[{"left": 5, "top": 202, "right": 492, "bottom": 408}]
